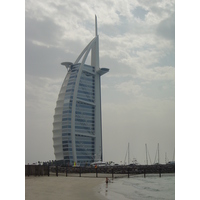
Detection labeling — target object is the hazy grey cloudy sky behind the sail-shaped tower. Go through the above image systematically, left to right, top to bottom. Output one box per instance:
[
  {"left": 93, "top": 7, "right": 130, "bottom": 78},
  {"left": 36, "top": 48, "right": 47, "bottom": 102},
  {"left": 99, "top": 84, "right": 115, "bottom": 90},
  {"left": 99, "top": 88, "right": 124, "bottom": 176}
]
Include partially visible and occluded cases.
[{"left": 25, "top": 0, "right": 175, "bottom": 164}]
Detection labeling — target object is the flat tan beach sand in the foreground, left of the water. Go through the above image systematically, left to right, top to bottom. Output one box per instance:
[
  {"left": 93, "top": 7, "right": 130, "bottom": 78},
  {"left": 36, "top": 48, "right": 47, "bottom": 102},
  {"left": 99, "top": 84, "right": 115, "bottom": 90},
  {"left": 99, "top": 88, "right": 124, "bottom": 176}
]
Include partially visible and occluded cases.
[{"left": 25, "top": 176, "right": 106, "bottom": 200}]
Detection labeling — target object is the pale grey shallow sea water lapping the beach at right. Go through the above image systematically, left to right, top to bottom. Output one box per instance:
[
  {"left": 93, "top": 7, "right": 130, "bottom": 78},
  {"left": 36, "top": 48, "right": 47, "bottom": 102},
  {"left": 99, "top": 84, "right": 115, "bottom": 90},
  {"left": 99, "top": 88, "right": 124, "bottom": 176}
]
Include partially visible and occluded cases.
[{"left": 100, "top": 174, "right": 175, "bottom": 200}]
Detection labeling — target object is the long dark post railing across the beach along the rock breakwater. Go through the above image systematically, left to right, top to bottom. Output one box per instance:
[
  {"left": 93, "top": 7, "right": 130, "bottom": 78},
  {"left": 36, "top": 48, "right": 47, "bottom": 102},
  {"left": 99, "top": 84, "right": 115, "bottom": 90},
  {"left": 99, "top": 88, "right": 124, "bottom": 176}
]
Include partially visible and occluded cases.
[{"left": 25, "top": 165, "right": 175, "bottom": 178}]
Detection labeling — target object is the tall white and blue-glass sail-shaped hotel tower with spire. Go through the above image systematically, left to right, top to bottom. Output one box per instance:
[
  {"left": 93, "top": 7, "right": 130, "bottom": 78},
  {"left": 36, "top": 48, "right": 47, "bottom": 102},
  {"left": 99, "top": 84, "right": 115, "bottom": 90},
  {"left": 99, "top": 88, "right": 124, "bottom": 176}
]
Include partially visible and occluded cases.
[{"left": 53, "top": 16, "right": 109, "bottom": 166}]
